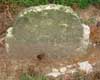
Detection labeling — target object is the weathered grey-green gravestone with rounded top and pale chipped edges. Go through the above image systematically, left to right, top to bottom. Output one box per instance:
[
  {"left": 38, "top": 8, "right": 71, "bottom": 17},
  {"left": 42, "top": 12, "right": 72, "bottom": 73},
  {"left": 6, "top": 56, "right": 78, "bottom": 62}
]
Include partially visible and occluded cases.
[{"left": 6, "top": 4, "right": 89, "bottom": 59}]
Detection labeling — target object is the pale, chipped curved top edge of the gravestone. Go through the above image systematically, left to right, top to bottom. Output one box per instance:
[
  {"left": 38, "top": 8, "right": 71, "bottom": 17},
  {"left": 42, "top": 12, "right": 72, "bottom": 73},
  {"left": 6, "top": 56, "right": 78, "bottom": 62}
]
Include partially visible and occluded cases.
[{"left": 18, "top": 4, "right": 79, "bottom": 18}]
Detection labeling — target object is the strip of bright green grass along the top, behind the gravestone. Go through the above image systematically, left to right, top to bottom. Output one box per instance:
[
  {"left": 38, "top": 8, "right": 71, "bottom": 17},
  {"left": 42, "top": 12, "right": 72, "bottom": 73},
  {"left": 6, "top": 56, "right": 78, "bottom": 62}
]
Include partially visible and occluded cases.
[{"left": 0, "top": 0, "right": 100, "bottom": 8}]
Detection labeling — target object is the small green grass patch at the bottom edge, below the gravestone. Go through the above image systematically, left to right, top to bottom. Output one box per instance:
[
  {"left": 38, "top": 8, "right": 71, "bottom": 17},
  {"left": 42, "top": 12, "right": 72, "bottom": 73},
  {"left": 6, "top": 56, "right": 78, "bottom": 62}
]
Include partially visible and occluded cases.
[{"left": 20, "top": 74, "right": 47, "bottom": 80}]
